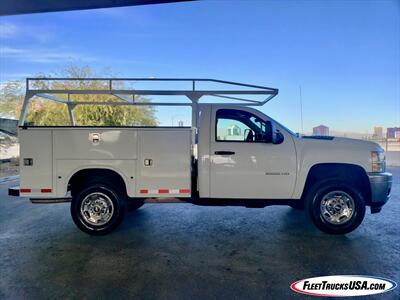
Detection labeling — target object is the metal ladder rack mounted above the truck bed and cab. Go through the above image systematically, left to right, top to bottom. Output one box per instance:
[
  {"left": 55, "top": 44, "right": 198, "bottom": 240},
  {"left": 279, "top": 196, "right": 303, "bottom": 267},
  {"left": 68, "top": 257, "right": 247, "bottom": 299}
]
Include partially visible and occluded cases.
[{"left": 19, "top": 77, "right": 278, "bottom": 128}]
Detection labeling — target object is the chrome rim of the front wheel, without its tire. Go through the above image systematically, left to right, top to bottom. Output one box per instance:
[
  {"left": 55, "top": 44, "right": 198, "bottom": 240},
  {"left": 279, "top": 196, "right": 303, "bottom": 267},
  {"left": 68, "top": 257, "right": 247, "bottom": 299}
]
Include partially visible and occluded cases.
[{"left": 320, "top": 191, "right": 355, "bottom": 225}]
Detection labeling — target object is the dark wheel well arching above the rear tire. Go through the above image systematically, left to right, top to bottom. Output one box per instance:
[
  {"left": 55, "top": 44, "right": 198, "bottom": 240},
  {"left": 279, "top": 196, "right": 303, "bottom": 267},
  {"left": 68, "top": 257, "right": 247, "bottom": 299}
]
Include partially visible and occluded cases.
[{"left": 68, "top": 169, "right": 127, "bottom": 196}]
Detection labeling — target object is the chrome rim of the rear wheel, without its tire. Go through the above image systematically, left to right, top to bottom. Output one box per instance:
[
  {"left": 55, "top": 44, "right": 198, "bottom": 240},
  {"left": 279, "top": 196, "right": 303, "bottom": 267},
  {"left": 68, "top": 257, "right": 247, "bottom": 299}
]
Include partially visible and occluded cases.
[{"left": 81, "top": 192, "right": 114, "bottom": 226}]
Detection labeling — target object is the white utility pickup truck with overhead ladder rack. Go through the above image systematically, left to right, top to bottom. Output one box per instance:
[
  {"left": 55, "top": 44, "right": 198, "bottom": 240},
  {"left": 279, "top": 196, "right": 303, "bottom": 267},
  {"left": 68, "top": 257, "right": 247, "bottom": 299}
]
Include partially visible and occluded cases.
[{"left": 9, "top": 78, "right": 392, "bottom": 235}]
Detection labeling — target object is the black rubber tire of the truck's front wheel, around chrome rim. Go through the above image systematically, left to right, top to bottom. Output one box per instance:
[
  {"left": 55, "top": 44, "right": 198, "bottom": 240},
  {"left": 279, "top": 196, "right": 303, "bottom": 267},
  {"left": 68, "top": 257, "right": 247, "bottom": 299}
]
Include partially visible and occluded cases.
[{"left": 306, "top": 180, "right": 365, "bottom": 234}]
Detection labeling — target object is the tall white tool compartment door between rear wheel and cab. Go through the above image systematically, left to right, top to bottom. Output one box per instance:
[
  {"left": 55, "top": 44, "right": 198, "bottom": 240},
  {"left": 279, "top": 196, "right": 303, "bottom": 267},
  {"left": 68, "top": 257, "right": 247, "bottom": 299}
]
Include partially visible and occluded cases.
[{"left": 136, "top": 128, "right": 191, "bottom": 198}]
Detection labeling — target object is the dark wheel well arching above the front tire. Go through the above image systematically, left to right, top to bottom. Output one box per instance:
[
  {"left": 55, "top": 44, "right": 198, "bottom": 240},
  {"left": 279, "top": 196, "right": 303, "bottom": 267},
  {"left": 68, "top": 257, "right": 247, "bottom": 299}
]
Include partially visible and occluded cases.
[{"left": 301, "top": 163, "right": 371, "bottom": 204}]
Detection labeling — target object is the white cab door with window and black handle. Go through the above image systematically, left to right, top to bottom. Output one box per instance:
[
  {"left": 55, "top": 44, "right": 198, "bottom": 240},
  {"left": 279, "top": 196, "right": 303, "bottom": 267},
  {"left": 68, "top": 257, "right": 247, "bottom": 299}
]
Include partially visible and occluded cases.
[{"left": 210, "top": 107, "right": 296, "bottom": 199}]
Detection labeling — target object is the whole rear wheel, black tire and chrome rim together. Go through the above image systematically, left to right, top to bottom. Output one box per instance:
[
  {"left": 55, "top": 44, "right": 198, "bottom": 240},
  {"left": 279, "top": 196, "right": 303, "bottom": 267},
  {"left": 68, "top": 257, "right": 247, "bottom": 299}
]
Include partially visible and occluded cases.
[{"left": 71, "top": 183, "right": 125, "bottom": 235}]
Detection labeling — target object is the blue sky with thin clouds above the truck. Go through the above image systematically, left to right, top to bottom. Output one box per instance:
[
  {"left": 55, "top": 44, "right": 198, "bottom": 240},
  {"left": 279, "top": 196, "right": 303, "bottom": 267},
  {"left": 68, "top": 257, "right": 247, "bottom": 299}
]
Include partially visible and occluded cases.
[{"left": 0, "top": 0, "right": 400, "bottom": 133}]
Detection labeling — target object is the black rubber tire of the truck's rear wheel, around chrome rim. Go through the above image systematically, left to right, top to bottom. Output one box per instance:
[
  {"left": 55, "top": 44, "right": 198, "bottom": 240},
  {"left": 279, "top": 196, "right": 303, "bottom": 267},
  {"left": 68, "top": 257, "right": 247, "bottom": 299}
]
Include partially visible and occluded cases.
[{"left": 71, "top": 183, "right": 125, "bottom": 235}]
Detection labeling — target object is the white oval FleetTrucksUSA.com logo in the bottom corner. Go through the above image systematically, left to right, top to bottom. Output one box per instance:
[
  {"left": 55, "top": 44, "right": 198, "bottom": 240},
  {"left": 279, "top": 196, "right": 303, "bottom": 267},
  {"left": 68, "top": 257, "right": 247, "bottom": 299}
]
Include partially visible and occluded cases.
[{"left": 290, "top": 275, "right": 397, "bottom": 297}]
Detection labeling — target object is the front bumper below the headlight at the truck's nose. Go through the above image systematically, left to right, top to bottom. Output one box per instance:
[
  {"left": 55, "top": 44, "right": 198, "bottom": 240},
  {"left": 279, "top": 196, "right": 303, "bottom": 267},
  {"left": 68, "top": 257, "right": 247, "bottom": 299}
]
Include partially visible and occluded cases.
[{"left": 368, "top": 172, "right": 392, "bottom": 213}]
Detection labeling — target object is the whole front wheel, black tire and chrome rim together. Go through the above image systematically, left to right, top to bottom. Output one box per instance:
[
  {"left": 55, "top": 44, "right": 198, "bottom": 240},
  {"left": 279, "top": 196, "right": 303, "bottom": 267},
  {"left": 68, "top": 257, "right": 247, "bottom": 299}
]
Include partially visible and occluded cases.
[{"left": 306, "top": 181, "right": 365, "bottom": 234}]
